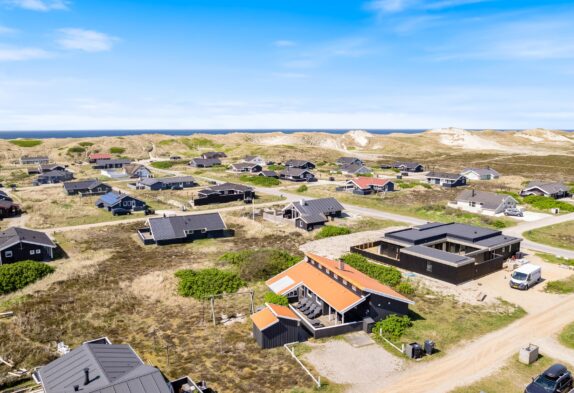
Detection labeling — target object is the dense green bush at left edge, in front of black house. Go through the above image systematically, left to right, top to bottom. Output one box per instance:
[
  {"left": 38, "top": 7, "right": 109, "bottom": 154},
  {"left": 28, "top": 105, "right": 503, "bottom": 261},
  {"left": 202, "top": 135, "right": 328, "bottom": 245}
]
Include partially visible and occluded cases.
[{"left": 0, "top": 261, "right": 54, "bottom": 295}]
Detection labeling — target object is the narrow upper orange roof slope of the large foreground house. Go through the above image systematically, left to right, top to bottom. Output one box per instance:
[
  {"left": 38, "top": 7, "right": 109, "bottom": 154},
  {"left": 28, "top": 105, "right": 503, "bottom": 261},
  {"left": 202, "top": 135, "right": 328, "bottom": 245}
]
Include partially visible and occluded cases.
[{"left": 307, "top": 253, "right": 414, "bottom": 304}]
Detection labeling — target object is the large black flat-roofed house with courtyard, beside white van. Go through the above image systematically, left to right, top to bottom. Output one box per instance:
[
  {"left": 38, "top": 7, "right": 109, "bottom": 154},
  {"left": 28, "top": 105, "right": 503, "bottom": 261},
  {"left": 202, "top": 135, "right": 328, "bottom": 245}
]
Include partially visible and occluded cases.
[{"left": 351, "top": 222, "right": 522, "bottom": 284}]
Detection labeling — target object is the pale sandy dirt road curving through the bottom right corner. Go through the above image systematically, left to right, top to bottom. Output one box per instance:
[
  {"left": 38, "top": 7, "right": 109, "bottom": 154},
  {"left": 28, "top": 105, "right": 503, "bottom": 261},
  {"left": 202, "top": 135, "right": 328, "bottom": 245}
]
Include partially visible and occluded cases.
[{"left": 376, "top": 296, "right": 574, "bottom": 393}]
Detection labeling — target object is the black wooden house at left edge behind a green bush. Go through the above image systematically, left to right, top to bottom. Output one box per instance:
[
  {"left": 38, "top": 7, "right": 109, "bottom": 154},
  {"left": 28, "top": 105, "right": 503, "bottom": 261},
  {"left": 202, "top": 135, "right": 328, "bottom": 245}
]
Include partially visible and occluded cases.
[{"left": 0, "top": 227, "right": 56, "bottom": 265}]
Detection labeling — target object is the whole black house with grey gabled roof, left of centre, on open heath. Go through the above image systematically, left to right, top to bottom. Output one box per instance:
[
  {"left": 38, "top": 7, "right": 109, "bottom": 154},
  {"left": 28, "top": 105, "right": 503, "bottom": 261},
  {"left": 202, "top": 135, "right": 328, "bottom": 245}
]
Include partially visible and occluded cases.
[{"left": 138, "top": 213, "right": 233, "bottom": 245}]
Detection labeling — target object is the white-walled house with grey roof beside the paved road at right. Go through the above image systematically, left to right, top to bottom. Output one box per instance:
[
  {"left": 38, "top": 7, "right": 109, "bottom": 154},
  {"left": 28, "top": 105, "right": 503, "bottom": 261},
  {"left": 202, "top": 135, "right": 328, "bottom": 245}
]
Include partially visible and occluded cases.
[{"left": 455, "top": 189, "right": 518, "bottom": 215}]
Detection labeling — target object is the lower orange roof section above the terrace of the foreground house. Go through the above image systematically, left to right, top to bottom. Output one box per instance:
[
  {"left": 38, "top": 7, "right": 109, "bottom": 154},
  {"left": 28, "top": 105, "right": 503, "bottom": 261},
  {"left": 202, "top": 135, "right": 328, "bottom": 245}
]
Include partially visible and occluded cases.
[{"left": 266, "top": 261, "right": 362, "bottom": 312}]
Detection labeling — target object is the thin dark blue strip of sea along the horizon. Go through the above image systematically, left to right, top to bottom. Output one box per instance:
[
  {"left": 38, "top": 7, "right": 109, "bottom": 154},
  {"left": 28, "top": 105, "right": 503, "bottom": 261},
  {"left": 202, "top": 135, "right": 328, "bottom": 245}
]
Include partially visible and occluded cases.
[{"left": 0, "top": 129, "right": 560, "bottom": 139}]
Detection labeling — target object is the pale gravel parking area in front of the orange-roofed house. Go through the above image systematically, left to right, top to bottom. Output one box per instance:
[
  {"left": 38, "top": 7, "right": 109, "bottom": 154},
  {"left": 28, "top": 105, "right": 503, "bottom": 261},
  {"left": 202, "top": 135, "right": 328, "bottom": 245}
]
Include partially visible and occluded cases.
[{"left": 304, "top": 340, "right": 404, "bottom": 393}]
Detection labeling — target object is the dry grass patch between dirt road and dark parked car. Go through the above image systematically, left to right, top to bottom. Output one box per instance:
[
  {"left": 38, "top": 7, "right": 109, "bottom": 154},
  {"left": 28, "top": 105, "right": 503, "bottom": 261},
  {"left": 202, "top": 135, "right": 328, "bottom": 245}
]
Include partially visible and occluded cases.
[{"left": 450, "top": 356, "right": 572, "bottom": 393}]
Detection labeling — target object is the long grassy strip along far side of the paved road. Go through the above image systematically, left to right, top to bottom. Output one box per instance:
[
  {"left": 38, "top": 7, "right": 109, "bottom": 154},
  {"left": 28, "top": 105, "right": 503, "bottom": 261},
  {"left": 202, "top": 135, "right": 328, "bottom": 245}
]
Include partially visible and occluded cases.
[{"left": 294, "top": 185, "right": 516, "bottom": 228}]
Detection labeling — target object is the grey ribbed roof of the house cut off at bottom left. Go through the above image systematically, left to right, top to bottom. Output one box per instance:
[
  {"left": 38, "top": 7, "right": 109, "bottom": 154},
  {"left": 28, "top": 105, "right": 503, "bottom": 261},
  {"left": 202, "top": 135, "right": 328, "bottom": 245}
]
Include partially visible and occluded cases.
[{"left": 39, "top": 343, "right": 170, "bottom": 393}]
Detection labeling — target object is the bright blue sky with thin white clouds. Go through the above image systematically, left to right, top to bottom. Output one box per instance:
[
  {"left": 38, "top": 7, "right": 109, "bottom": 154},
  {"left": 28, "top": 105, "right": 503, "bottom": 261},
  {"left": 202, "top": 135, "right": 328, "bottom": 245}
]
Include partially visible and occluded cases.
[{"left": 0, "top": 0, "right": 574, "bottom": 130}]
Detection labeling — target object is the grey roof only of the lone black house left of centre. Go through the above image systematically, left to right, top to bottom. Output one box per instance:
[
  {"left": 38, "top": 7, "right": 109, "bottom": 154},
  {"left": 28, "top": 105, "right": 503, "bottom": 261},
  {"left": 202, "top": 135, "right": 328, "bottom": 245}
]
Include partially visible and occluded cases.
[{"left": 149, "top": 213, "right": 227, "bottom": 241}]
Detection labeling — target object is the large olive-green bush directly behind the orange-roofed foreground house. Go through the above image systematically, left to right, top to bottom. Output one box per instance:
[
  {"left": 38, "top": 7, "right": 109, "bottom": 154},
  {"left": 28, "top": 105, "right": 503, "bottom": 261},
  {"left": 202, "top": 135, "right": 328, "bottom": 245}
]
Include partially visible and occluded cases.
[{"left": 219, "top": 248, "right": 301, "bottom": 281}]
